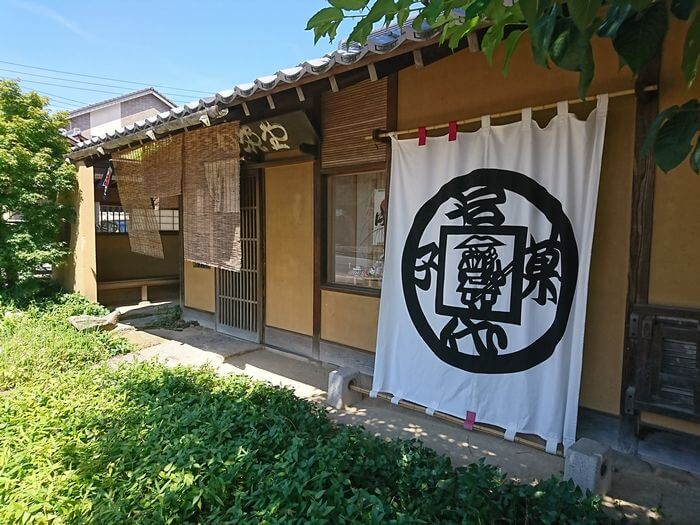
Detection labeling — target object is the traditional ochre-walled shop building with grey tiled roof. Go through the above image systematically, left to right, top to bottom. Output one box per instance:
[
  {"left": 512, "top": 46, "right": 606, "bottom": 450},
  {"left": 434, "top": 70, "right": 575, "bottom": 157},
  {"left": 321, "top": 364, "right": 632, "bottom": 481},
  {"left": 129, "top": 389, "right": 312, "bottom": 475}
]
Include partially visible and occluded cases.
[{"left": 64, "top": 20, "right": 700, "bottom": 466}]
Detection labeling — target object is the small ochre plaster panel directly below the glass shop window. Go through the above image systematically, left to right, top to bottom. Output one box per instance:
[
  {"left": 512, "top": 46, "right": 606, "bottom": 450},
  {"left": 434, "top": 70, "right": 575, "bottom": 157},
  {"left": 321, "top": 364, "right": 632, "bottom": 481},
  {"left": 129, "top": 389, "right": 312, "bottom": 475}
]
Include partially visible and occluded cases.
[{"left": 321, "top": 290, "right": 379, "bottom": 352}]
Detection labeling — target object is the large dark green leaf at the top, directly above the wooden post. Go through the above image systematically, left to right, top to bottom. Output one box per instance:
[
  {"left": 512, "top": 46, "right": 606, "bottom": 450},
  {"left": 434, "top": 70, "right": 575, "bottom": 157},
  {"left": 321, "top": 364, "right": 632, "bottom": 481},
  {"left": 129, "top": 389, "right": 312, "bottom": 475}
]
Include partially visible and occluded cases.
[{"left": 613, "top": 2, "right": 668, "bottom": 75}]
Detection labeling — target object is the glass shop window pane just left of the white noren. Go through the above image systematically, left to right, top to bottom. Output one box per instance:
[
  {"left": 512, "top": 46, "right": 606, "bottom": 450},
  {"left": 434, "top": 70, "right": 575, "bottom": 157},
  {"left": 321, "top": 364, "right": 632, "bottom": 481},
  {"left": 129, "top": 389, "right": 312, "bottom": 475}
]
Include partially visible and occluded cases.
[{"left": 326, "top": 172, "right": 386, "bottom": 289}]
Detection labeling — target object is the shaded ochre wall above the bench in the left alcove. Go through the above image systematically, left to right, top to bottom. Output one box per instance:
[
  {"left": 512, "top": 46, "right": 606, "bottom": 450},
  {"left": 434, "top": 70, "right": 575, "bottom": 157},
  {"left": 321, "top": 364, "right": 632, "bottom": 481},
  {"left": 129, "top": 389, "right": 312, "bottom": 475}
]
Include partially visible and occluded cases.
[{"left": 96, "top": 234, "right": 180, "bottom": 282}]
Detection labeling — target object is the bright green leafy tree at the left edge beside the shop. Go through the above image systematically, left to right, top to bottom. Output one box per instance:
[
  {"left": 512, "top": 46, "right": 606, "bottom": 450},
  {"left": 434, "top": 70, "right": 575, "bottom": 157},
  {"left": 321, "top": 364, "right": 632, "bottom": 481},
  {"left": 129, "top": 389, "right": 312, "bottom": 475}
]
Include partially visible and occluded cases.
[{"left": 0, "top": 81, "right": 75, "bottom": 289}]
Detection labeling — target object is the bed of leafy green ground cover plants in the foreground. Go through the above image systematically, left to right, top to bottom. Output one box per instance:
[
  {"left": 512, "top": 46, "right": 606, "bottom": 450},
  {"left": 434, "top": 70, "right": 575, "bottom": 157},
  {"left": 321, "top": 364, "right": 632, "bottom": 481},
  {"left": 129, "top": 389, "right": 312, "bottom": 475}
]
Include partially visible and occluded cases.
[{"left": 0, "top": 296, "right": 610, "bottom": 524}]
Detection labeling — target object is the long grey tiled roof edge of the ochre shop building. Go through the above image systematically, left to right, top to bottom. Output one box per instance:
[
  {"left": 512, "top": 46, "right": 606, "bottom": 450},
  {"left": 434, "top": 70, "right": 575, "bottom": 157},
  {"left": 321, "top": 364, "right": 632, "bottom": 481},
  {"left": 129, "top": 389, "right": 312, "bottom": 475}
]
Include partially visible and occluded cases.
[{"left": 65, "top": 24, "right": 439, "bottom": 158}]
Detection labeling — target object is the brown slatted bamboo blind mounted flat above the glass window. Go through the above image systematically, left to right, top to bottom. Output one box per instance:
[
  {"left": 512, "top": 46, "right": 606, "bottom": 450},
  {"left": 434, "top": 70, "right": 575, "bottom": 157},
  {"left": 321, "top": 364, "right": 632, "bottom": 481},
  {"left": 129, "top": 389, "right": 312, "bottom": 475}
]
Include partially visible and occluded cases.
[{"left": 321, "top": 78, "right": 388, "bottom": 168}]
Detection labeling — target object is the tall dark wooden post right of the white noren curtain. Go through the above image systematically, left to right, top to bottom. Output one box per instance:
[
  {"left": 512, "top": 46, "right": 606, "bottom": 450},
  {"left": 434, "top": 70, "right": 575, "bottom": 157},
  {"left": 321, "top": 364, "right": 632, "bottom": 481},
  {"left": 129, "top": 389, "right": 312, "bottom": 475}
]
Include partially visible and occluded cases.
[{"left": 618, "top": 57, "right": 661, "bottom": 453}]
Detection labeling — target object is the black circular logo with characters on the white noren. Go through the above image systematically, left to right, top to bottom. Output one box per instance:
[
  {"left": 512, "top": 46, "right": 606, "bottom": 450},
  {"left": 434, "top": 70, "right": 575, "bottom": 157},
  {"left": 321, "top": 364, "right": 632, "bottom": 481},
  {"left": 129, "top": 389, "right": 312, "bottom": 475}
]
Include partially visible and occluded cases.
[{"left": 401, "top": 169, "right": 578, "bottom": 374}]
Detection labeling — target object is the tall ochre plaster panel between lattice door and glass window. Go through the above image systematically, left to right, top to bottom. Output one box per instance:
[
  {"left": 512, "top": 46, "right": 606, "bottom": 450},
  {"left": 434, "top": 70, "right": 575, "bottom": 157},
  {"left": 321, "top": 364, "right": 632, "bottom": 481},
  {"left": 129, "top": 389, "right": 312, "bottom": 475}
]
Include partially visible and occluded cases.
[{"left": 265, "top": 162, "right": 314, "bottom": 335}]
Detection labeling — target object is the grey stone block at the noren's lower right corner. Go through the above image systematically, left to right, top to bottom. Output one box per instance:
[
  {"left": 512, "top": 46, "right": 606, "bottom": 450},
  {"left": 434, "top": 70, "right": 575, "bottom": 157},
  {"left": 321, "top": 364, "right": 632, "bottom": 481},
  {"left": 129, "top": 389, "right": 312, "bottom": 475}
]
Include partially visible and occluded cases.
[{"left": 564, "top": 438, "right": 612, "bottom": 496}]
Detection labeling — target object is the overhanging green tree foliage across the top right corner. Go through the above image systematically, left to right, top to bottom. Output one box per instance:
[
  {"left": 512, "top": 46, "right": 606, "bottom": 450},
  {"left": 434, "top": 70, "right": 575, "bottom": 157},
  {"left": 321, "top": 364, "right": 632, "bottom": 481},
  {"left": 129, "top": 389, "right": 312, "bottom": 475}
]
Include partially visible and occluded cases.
[{"left": 307, "top": 0, "right": 700, "bottom": 173}]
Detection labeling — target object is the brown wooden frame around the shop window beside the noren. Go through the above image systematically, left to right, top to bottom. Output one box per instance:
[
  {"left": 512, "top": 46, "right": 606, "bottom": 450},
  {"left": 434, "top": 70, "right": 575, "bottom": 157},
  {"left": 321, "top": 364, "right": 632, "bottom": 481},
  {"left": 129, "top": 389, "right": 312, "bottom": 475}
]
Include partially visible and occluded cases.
[{"left": 320, "top": 159, "right": 390, "bottom": 297}]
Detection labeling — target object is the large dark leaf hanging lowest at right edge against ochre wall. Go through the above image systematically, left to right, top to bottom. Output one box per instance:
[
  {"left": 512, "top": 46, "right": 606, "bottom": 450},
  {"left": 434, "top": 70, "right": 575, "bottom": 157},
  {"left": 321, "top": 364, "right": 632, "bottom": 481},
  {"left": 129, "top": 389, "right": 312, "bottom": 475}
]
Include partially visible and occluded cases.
[{"left": 654, "top": 100, "right": 700, "bottom": 172}]
